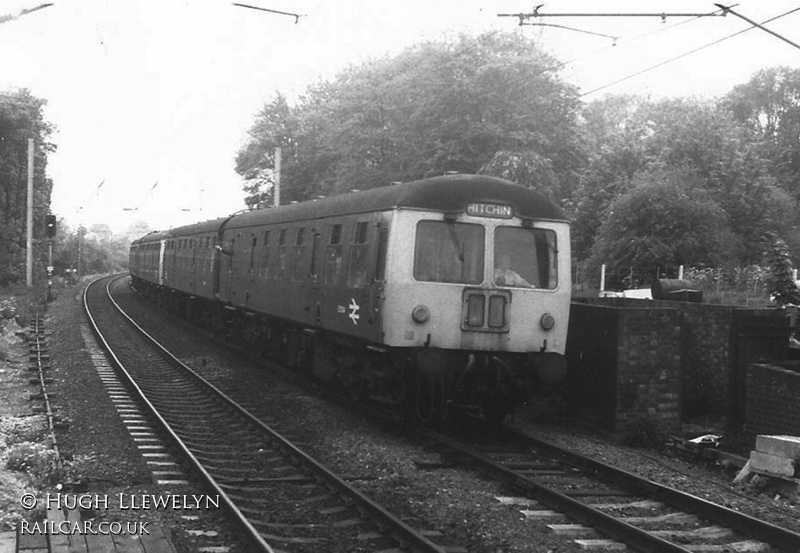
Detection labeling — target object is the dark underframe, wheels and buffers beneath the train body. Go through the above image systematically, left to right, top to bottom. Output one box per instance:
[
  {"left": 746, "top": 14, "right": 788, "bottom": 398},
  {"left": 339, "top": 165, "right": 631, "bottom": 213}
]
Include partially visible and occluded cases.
[{"left": 131, "top": 280, "right": 566, "bottom": 423}]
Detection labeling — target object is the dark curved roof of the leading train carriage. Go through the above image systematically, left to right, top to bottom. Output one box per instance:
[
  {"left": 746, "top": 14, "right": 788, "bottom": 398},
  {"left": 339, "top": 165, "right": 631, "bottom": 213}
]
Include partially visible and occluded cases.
[{"left": 226, "top": 175, "right": 567, "bottom": 228}]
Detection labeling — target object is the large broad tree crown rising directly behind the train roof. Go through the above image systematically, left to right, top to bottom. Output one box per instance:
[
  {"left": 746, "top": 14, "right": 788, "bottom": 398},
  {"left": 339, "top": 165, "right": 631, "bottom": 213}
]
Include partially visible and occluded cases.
[{"left": 236, "top": 33, "right": 581, "bottom": 205}]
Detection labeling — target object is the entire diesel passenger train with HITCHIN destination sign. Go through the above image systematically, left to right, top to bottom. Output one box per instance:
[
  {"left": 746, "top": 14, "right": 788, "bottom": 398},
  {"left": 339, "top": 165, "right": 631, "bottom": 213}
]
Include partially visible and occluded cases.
[{"left": 130, "top": 175, "right": 571, "bottom": 421}]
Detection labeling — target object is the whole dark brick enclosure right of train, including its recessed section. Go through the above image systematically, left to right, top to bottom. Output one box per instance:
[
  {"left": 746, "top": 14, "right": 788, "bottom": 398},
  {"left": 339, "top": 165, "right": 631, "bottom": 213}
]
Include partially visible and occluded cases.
[{"left": 567, "top": 298, "right": 789, "bottom": 429}]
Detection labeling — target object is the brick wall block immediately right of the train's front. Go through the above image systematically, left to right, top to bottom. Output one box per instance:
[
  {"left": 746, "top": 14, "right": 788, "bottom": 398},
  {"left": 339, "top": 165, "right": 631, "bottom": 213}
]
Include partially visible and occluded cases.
[{"left": 565, "top": 303, "right": 681, "bottom": 433}]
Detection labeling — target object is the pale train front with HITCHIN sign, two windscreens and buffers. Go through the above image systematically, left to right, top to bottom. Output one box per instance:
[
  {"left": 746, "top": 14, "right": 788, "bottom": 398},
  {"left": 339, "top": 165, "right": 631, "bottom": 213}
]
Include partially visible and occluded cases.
[{"left": 386, "top": 192, "right": 571, "bottom": 421}]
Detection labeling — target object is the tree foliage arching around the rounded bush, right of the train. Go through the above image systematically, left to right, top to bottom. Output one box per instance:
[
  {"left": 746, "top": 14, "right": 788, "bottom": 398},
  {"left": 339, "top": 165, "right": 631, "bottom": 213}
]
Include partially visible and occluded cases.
[{"left": 572, "top": 92, "right": 800, "bottom": 265}]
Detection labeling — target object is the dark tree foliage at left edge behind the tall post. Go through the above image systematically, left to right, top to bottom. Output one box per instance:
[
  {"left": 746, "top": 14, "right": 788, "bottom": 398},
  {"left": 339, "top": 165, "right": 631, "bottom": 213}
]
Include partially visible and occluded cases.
[{"left": 0, "top": 90, "right": 55, "bottom": 287}]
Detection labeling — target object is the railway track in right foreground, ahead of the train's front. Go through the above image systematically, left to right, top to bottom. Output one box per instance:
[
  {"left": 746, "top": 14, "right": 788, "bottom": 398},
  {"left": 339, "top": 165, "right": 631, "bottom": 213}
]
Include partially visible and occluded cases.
[{"left": 418, "top": 427, "right": 800, "bottom": 553}]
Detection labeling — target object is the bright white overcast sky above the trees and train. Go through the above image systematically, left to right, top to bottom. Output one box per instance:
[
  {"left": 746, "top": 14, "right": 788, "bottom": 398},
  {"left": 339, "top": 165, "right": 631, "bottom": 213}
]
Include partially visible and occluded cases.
[{"left": 0, "top": 0, "right": 800, "bottom": 231}]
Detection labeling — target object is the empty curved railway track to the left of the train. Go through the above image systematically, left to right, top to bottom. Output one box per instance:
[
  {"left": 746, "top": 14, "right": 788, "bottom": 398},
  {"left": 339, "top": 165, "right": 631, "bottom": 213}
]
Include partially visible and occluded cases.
[{"left": 84, "top": 277, "right": 463, "bottom": 553}]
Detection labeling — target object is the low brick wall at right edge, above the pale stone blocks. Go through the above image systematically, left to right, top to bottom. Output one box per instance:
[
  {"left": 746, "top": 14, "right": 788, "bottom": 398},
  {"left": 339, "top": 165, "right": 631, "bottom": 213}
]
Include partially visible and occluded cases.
[{"left": 745, "top": 363, "right": 800, "bottom": 436}]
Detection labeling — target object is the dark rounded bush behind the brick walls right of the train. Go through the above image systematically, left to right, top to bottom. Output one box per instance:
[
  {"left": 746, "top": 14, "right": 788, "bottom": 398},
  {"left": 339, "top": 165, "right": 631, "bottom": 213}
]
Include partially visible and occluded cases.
[{"left": 591, "top": 168, "right": 734, "bottom": 279}]
